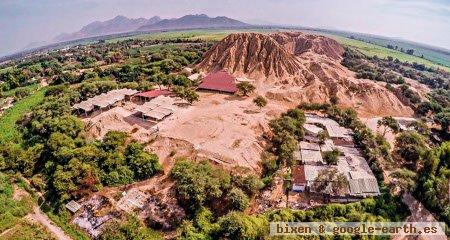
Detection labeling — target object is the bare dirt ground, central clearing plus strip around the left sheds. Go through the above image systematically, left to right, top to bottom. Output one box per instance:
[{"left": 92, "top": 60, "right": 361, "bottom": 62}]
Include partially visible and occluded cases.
[{"left": 83, "top": 92, "right": 287, "bottom": 171}]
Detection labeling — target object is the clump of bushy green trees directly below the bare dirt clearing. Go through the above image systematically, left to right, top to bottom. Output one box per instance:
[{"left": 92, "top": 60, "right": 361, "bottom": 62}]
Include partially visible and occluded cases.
[{"left": 171, "top": 159, "right": 264, "bottom": 214}]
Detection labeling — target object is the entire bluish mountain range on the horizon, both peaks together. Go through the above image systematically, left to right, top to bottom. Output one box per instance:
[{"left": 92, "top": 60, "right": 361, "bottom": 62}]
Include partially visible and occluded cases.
[{"left": 53, "top": 14, "right": 250, "bottom": 42}]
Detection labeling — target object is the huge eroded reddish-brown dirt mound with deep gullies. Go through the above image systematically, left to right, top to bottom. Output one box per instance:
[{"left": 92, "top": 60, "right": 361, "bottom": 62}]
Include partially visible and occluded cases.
[{"left": 198, "top": 32, "right": 413, "bottom": 116}]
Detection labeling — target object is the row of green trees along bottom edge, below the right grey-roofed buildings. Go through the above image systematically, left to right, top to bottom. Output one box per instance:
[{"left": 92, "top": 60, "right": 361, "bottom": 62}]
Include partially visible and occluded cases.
[{"left": 178, "top": 197, "right": 407, "bottom": 240}]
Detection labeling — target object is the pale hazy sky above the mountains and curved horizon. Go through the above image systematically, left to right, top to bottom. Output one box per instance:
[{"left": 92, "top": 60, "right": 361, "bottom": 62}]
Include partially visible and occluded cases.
[{"left": 0, "top": 0, "right": 450, "bottom": 55}]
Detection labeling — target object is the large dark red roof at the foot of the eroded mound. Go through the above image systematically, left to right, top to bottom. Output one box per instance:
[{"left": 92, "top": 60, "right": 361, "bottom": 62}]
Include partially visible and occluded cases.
[{"left": 198, "top": 71, "right": 238, "bottom": 93}]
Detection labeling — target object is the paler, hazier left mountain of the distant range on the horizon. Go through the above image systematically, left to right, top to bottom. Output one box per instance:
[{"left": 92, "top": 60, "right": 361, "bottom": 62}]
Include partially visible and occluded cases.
[{"left": 53, "top": 15, "right": 161, "bottom": 42}]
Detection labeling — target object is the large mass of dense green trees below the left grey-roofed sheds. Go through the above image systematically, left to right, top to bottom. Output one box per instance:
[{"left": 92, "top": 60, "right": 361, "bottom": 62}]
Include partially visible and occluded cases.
[{"left": 0, "top": 83, "right": 161, "bottom": 205}]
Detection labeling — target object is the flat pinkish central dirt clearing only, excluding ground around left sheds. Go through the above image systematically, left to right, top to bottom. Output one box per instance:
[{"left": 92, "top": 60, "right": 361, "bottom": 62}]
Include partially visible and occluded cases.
[{"left": 158, "top": 92, "right": 285, "bottom": 171}]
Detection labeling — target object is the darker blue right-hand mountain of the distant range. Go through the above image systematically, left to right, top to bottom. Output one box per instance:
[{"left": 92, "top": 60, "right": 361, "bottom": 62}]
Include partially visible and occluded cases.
[{"left": 138, "top": 14, "right": 251, "bottom": 31}]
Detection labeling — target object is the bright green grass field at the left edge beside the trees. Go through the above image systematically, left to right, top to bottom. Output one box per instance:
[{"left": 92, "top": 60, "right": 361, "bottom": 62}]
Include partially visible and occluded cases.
[{"left": 0, "top": 88, "right": 45, "bottom": 143}]
